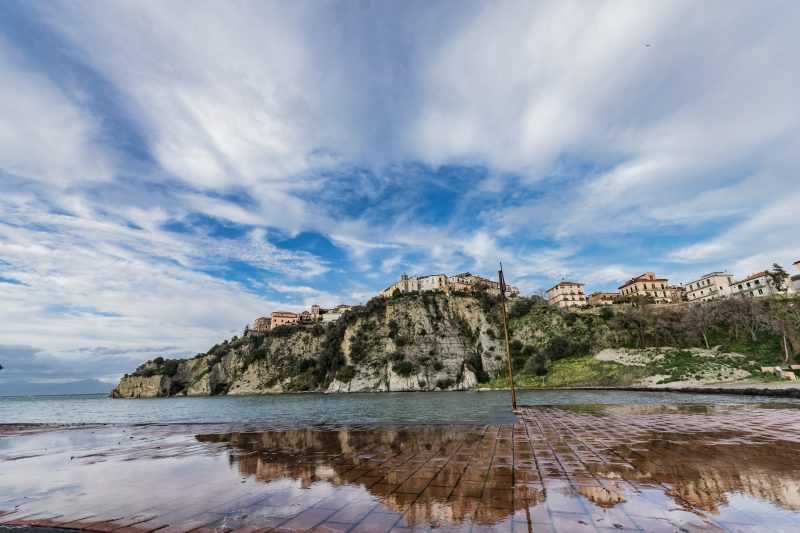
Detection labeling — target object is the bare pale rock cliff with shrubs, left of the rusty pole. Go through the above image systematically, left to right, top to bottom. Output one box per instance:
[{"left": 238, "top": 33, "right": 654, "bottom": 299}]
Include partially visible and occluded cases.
[{"left": 113, "top": 293, "right": 505, "bottom": 398}]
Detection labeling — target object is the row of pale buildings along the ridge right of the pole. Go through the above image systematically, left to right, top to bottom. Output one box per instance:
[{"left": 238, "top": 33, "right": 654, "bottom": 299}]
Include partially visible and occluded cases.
[{"left": 547, "top": 261, "right": 800, "bottom": 308}]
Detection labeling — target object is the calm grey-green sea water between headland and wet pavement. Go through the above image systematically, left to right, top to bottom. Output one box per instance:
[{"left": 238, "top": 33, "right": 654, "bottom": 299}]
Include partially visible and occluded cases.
[{"left": 0, "top": 391, "right": 800, "bottom": 427}]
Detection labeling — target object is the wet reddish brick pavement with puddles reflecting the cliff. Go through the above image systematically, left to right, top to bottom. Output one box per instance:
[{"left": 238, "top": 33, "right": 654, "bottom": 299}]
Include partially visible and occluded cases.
[{"left": 0, "top": 404, "right": 800, "bottom": 533}]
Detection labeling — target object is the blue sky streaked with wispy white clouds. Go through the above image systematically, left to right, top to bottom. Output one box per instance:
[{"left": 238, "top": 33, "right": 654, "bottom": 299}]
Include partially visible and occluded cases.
[{"left": 0, "top": 0, "right": 800, "bottom": 394}]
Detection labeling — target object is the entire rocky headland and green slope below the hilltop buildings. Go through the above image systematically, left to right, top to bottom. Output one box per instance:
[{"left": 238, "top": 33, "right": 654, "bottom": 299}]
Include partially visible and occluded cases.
[{"left": 115, "top": 293, "right": 800, "bottom": 397}]
